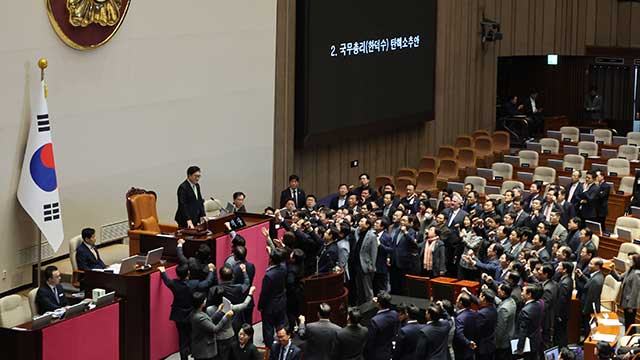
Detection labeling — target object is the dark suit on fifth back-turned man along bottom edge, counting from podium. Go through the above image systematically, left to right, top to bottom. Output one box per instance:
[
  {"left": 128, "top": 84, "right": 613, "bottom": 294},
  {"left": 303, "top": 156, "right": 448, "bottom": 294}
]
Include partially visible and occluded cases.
[{"left": 415, "top": 320, "right": 451, "bottom": 360}]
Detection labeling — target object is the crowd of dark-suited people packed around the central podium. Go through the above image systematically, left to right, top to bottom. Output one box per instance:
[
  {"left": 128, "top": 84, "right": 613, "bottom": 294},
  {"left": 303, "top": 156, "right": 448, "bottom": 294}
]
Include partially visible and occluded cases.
[{"left": 39, "top": 171, "right": 640, "bottom": 360}]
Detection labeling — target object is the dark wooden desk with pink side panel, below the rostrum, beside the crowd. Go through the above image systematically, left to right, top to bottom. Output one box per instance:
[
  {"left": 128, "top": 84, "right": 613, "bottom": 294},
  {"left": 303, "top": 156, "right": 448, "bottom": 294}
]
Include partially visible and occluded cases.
[{"left": 85, "top": 262, "right": 178, "bottom": 360}]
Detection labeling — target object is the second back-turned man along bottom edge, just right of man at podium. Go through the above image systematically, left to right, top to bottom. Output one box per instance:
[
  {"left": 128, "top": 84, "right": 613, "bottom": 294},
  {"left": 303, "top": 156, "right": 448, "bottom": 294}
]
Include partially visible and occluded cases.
[{"left": 331, "top": 307, "right": 368, "bottom": 360}]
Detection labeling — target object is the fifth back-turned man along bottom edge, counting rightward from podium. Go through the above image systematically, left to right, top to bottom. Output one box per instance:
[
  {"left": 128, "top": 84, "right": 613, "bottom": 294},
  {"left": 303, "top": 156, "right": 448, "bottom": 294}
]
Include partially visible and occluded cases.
[{"left": 415, "top": 304, "right": 451, "bottom": 360}]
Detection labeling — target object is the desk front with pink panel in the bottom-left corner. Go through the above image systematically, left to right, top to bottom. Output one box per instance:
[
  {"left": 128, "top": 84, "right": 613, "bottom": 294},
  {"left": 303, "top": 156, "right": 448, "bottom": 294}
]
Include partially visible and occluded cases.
[{"left": 0, "top": 301, "right": 120, "bottom": 360}]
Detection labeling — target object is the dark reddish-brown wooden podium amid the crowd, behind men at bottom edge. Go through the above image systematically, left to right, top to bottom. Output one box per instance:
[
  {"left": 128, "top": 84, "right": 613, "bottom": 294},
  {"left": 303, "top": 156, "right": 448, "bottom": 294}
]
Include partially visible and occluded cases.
[{"left": 302, "top": 271, "right": 349, "bottom": 326}]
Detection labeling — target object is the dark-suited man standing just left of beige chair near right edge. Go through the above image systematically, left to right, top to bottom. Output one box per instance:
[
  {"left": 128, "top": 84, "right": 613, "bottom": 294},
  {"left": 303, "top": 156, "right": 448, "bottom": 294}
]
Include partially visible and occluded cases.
[{"left": 576, "top": 257, "right": 604, "bottom": 338}]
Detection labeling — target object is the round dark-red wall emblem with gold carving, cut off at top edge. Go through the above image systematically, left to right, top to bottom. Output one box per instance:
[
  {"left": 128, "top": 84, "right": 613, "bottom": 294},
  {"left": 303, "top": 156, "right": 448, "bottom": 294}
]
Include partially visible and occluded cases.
[{"left": 45, "top": 0, "right": 130, "bottom": 50}]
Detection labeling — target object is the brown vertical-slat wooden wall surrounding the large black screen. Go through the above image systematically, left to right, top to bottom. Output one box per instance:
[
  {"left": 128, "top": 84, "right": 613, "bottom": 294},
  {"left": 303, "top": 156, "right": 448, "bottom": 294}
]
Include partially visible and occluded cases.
[{"left": 274, "top": 0, "right": 640, "bottom": 202}]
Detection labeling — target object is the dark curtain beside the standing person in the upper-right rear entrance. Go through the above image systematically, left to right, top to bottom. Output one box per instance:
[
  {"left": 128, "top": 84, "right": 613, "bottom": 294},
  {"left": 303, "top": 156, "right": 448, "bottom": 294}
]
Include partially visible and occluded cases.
[{"left": 584, "top": 65, "right": 634, "bottom": 135}]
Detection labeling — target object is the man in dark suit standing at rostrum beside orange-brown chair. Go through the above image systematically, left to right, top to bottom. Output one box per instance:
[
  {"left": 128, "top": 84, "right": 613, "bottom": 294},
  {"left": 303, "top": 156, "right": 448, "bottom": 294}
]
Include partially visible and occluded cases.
[{"left": 175, "top": 166, "right": 205, "bottom": 229}]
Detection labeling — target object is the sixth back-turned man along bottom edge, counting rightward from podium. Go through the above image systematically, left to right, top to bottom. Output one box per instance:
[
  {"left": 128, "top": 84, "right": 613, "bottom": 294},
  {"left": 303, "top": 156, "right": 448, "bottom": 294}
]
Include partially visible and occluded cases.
[{"left": 453, "top": 292, "right": 479, "bottom": 360}]
